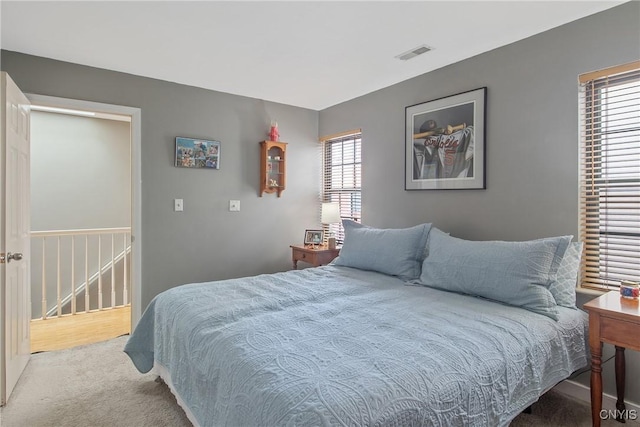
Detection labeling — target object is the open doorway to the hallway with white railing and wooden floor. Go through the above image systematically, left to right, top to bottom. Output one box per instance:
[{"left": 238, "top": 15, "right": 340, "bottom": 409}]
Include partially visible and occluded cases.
[{"left": 27, "top": 94, "right": 141, "bottom": 351}]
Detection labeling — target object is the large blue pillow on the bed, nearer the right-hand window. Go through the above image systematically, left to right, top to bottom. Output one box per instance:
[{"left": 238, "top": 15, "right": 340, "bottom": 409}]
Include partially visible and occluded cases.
[{"left": 420, "top": 233, "right": 572, "bottom": 320}]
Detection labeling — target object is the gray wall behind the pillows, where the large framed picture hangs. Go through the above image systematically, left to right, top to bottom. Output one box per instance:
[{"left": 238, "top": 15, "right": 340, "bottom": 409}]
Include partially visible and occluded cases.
[{"left": 320, "top": 1, "right": 640, "bottom": 408}]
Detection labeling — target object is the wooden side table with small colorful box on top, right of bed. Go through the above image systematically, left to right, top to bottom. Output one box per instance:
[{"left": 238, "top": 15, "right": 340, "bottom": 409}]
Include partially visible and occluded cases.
[{"left": 584, "top": 291, "right": 640, "bottom": 427}]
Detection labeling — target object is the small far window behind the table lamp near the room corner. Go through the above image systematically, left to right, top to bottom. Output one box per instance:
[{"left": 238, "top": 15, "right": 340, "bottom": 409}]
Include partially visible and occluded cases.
[{"left": 320, "top": 129, "right": 362, "bottom": 243}]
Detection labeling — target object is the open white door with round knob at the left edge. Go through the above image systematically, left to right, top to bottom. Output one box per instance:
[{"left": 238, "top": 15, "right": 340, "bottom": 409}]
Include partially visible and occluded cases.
[{"left": 0, "top": 72, "right": 31, "bottom": 405}]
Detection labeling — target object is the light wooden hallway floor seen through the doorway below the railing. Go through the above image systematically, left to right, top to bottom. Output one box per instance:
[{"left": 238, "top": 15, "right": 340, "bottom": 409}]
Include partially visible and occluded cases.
[{"left": 31, "top": 305, "right": 131, "bottom": 353}]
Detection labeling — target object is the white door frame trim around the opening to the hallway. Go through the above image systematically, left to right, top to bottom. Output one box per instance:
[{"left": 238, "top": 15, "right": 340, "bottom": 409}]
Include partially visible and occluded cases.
[{"left": 25, "top": 93, "right": 142, "bottom": 331}]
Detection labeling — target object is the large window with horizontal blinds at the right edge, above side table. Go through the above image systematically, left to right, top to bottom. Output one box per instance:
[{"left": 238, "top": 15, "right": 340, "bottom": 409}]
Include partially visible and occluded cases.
[{"left": 580, "top": 61, "right": 640, "bottom": 288}]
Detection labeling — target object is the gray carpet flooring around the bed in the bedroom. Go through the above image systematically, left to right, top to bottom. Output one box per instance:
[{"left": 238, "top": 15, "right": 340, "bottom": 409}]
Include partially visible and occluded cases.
[{"left": 0, "top": 336, "right": 640, "bottom": 427}]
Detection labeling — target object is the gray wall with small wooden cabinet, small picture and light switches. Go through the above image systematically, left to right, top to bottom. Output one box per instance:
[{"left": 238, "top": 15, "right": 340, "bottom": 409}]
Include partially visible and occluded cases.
[{"left": 1, "top": 51, "right": 320, "bottom": 308}]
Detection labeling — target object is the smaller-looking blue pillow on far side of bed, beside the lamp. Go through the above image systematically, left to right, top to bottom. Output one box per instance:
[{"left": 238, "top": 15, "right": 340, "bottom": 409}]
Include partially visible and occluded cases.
[{"left": 333, "top": 220, "right": 431, "bottom": 280}]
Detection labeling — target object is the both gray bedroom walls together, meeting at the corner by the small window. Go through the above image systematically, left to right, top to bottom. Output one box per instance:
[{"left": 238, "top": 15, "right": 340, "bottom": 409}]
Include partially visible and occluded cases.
[{"left": 1, "top": 2, "right": 640, "bottom": 408}]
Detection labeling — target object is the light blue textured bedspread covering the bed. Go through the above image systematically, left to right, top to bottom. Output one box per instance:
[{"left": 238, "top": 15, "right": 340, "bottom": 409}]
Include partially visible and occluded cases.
[{"left": 125, "top": 266, "right": 587, "bottom": 426}]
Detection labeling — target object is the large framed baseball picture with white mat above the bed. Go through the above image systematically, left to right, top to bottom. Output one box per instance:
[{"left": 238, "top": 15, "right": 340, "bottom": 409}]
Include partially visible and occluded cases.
[{"left": 404, "top": 87, "right": 487, "bottom": 191}]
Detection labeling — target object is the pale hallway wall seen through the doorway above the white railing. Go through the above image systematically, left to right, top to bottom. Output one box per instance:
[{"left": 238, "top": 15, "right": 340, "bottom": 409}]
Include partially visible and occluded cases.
[{"left": 31, "top": 111, "right": 131, "bottom": 231}]
